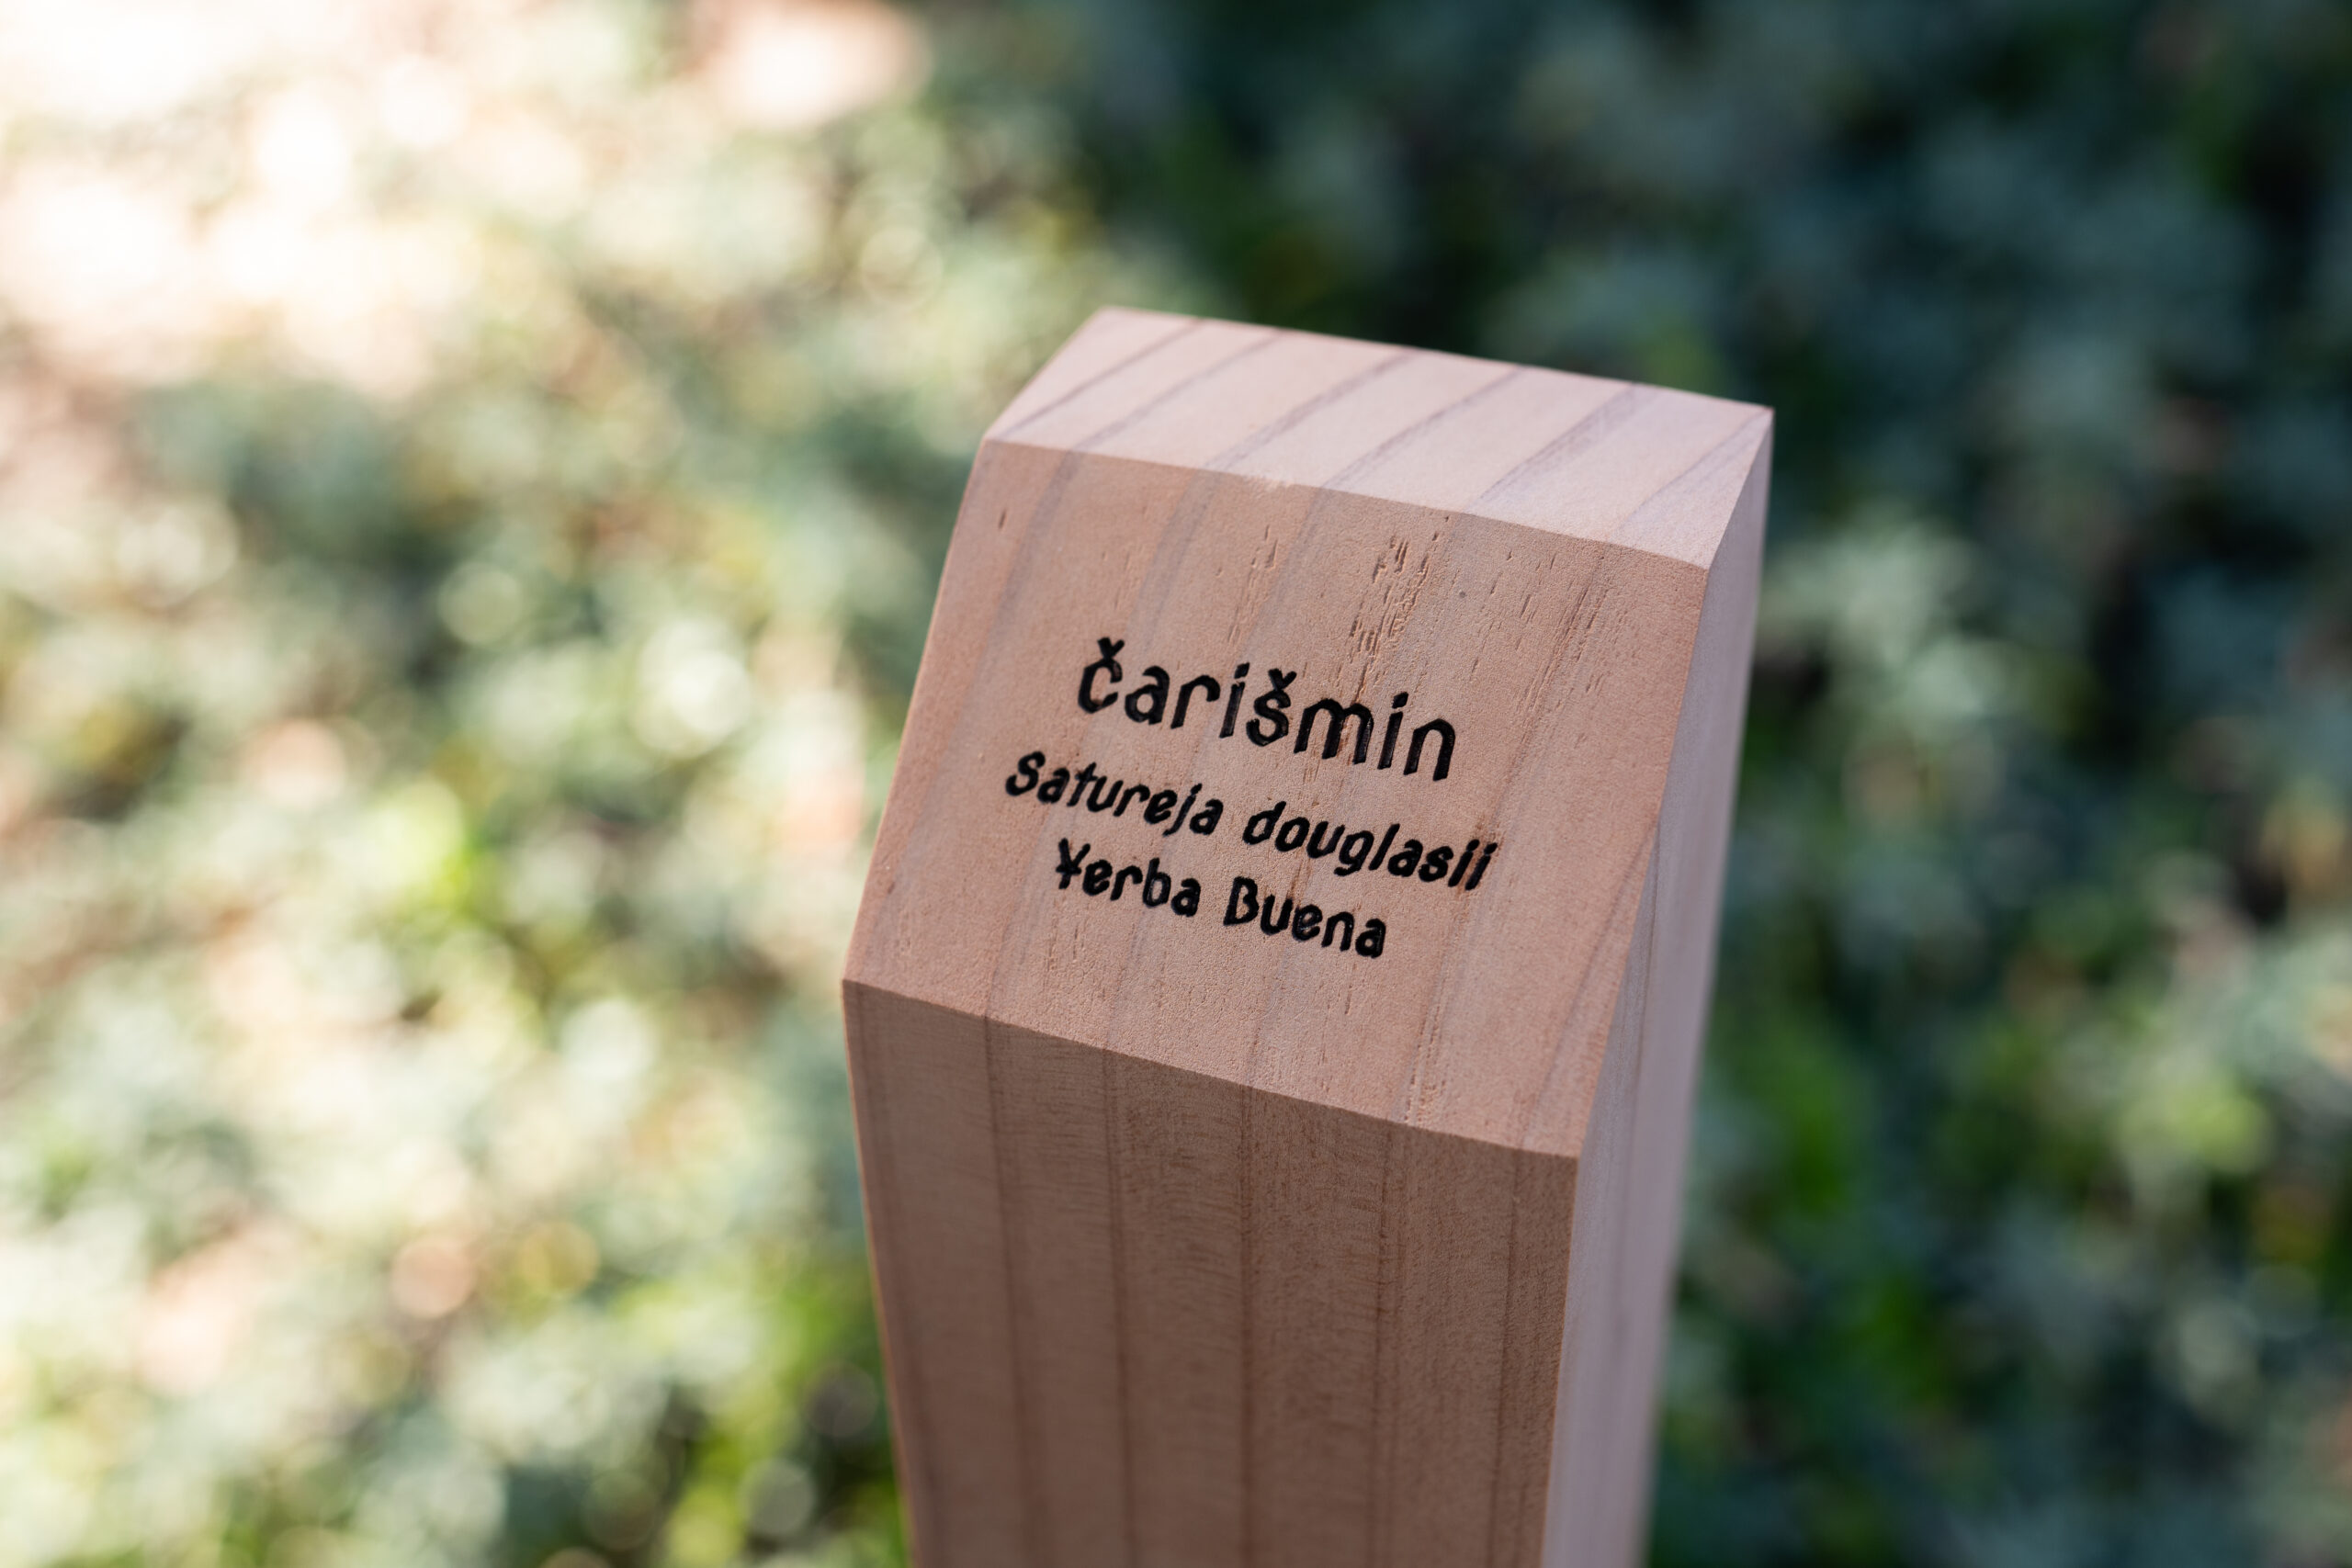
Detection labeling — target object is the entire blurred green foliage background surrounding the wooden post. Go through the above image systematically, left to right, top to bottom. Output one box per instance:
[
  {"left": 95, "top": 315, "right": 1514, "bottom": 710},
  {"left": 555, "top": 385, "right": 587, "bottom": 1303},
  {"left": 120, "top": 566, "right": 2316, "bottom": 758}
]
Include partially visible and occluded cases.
[{"left": 0, "top": 0, "right": 2352, "bottom": 1568}]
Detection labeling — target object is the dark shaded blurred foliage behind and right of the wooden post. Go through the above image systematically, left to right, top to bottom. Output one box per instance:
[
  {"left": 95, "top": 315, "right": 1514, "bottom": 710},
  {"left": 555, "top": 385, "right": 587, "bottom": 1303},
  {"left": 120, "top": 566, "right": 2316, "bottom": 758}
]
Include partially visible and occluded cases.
[{"left": 959, "top": 0, "right": 2352, "bottom": 1568}]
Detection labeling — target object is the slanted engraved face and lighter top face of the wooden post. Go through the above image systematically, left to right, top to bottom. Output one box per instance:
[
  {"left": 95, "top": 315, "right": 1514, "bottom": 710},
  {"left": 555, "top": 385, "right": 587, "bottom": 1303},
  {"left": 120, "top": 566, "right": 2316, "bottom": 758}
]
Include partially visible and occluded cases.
[{"left": 849, "top": 310, "right": 1771, "bottom": 1155}]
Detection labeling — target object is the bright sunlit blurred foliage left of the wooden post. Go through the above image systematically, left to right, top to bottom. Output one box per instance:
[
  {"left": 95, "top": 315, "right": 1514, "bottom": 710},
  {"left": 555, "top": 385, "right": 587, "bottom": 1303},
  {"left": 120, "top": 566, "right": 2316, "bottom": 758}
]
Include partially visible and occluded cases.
[{"left": 0, "top": 0, "right": 1150, "bottom": 1568}]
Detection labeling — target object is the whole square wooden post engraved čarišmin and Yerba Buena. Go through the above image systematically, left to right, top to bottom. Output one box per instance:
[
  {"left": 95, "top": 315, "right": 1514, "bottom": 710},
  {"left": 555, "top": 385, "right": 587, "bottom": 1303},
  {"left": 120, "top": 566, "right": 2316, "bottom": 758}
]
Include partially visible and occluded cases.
[{"left": 844, "top": 310, "right": 1771, "bottom": 1568}]
